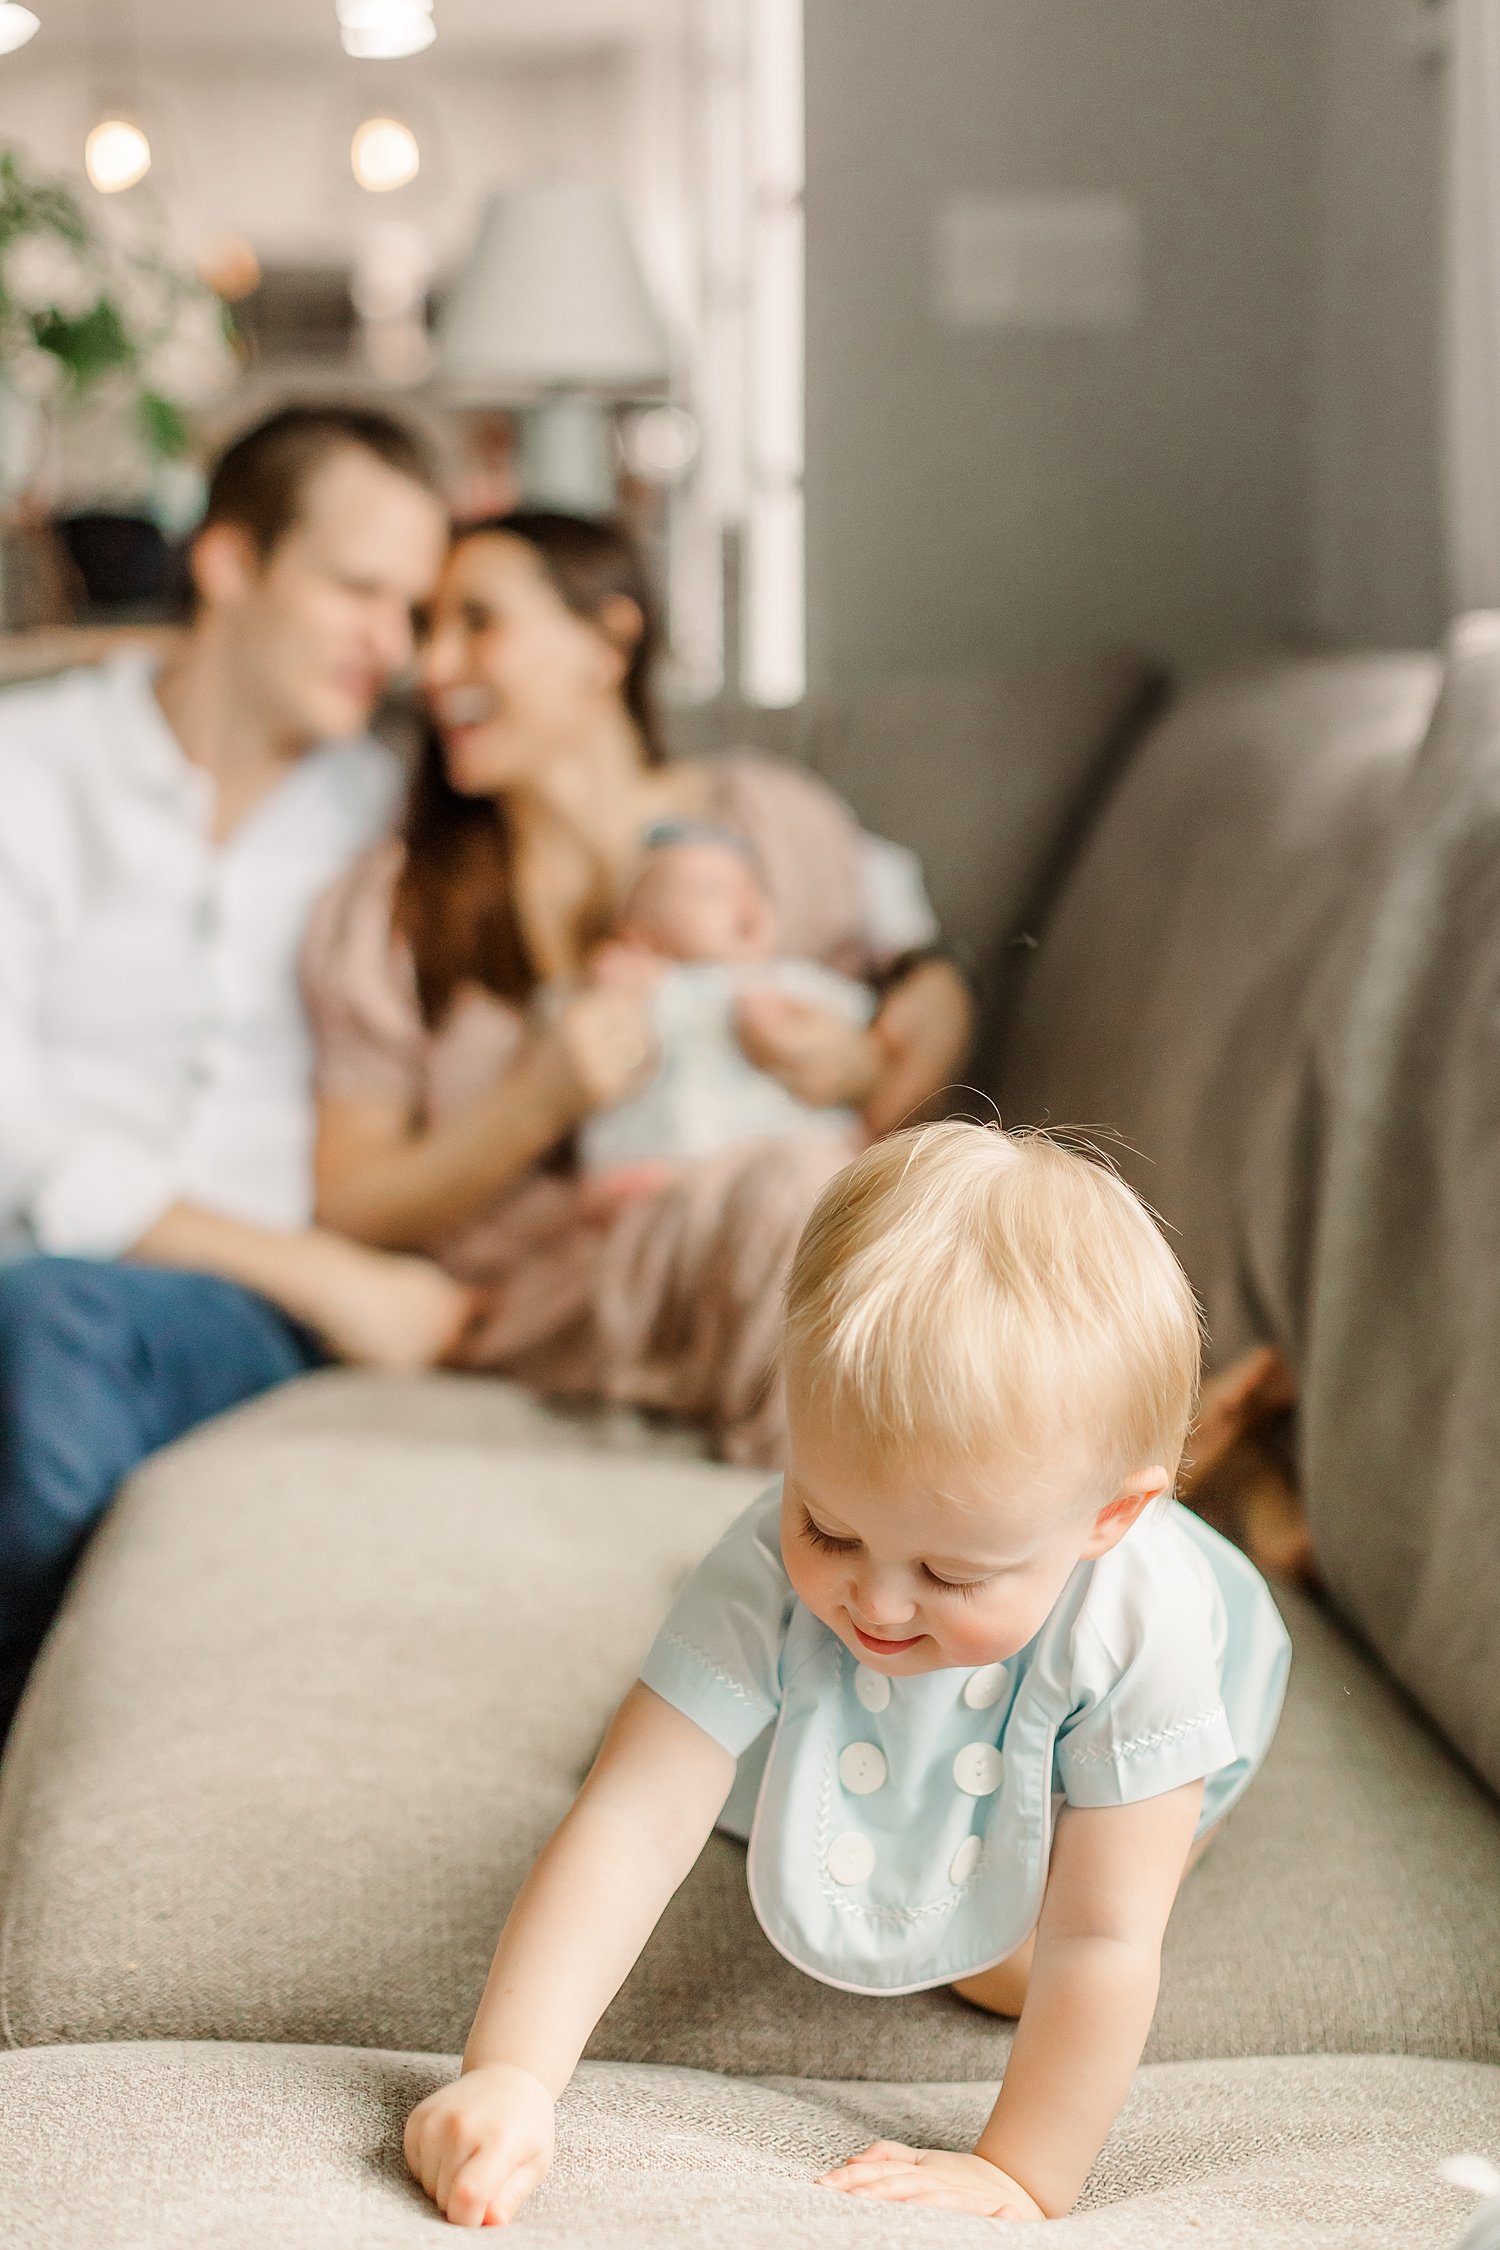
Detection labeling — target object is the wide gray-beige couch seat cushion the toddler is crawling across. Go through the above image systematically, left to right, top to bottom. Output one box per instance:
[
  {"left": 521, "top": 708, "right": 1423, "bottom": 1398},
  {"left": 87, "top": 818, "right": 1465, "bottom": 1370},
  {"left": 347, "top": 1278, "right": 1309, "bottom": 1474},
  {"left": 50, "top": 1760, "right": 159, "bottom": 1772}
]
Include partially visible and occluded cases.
[{"left": 0, "top": 1422, "right": 1500, "bottom": 2079}]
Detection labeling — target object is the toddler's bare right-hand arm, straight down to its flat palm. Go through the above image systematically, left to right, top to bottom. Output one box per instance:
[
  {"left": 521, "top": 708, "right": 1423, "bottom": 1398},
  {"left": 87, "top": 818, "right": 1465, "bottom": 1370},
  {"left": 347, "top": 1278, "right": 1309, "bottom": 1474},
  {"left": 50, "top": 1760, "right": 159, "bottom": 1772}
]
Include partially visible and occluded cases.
[{"left": 828, "top": 1782, "right": 1203, "bottom": 2219}]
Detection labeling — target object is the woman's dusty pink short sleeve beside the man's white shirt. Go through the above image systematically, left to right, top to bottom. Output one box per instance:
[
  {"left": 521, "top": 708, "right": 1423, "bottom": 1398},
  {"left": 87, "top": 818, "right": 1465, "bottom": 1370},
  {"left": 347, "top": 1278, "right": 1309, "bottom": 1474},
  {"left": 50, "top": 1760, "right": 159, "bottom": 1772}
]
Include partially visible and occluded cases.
[{"left": 301, "top": 842, "right": 427, "bottom": 1107}]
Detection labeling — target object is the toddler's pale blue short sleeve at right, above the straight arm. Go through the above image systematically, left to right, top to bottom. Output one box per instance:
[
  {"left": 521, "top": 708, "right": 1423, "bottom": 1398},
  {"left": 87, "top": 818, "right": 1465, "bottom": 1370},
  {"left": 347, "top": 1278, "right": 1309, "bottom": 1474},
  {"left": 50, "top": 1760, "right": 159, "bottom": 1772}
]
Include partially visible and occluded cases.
[{"left": 1057, "top": 1573, "right": 1235, "bottom": 1807}]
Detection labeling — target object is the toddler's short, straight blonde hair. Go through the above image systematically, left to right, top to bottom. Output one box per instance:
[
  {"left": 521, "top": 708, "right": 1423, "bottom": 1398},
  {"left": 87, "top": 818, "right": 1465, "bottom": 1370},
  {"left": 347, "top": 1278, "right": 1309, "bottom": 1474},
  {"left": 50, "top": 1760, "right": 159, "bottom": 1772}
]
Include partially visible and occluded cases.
[{"left": 785, "top": 1125, "right": 1201, "bottom": 1499}]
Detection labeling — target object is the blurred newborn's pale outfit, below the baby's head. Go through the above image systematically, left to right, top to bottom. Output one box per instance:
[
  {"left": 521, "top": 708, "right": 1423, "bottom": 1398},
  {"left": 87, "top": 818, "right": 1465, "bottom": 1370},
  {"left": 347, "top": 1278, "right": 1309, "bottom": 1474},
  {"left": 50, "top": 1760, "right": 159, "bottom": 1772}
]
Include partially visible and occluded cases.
[{"left": 578, "top": 959, "right": 875, "bottom": 1172}]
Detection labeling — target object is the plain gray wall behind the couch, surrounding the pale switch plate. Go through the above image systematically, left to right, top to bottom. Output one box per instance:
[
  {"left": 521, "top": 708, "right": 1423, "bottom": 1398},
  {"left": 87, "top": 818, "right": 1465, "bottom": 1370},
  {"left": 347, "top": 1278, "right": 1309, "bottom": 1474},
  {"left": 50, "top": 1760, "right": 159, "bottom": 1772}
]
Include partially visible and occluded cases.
[{"left": 807, "top": 0, "right": 1442, "bottom": 686}]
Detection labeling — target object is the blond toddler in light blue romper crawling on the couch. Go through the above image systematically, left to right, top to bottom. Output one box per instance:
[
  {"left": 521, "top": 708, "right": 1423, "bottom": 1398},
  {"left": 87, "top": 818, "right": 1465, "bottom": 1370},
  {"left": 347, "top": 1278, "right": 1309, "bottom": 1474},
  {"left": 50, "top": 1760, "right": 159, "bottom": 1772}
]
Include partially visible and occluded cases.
[{"left": 407, "top": 1125, "right": 1289, "bottom": 2225}]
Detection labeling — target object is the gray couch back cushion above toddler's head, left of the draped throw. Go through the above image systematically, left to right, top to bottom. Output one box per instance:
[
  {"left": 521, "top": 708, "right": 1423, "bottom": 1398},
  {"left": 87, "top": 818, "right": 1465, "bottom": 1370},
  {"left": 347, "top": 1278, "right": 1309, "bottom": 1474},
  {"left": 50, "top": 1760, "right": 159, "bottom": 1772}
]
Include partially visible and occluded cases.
[{"left": 998, "top": 655, "right": 1442, "bottom": 1357}]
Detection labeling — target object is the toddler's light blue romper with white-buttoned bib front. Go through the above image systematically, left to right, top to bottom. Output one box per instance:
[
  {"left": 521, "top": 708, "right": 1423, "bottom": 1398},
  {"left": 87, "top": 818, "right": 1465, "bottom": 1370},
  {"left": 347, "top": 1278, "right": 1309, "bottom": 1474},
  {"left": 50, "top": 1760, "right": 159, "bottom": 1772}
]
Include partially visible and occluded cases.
[{"left": 641, "top": 1483, "right": 1291, "bottom": 1994}]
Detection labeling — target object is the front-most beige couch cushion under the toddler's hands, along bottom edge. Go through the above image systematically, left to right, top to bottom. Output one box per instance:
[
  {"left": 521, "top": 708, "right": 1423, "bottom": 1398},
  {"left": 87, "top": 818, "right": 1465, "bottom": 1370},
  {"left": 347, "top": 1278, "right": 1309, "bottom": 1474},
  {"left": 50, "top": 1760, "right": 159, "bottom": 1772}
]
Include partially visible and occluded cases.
[{"left": 0, "top": 2045, "right": 1500, "bottom": 2250}]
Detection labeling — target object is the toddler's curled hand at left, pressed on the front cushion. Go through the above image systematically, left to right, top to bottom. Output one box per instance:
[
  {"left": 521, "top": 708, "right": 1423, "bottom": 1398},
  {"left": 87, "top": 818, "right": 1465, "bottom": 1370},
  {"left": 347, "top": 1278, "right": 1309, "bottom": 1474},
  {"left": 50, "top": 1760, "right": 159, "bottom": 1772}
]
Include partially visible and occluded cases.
[{"left": 405, "top": 2063, "right": 553, "bottom": 2228}]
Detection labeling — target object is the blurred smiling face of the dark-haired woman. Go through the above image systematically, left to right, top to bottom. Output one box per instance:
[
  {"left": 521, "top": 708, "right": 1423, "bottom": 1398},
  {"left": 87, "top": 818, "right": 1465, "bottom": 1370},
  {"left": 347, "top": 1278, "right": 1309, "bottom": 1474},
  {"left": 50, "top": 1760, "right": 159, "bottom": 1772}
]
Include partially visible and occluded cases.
[{"left": 423, "top": 531, "right": 639, "bottom": 797}]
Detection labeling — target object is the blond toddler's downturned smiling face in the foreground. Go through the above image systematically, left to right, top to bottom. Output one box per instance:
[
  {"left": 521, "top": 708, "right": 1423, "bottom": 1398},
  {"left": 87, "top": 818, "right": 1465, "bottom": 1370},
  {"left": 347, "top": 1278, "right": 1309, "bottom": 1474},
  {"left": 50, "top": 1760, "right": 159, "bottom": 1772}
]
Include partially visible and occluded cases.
[{"left": 780, "top": 1397, "right": 1167, "bottom": 1679}]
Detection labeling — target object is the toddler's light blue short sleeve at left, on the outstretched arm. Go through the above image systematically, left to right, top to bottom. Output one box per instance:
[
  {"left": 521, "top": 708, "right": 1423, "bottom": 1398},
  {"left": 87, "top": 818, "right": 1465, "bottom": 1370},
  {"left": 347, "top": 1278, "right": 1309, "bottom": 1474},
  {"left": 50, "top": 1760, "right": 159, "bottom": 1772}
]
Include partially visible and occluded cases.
[{"left": 641, "top": 1485, "right": 794, "bottom": 1757}]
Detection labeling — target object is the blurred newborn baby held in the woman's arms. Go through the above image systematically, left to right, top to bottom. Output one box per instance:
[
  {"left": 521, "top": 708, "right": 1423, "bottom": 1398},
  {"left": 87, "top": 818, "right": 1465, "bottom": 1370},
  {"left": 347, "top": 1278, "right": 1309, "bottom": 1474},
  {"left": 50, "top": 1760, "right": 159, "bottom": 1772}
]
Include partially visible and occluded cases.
[{"left": 580, "top": 821, "right": 875, "bottom": 1172}]
